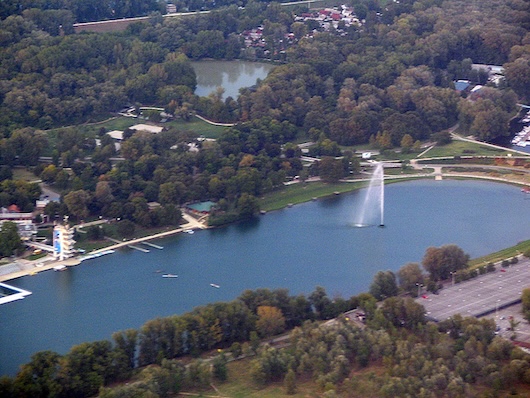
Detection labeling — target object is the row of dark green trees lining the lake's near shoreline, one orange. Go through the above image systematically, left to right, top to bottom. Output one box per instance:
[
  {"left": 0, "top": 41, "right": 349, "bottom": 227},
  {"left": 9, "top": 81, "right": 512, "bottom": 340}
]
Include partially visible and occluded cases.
[{"left": 0, "top": 288, "right": 358, "bottom": 397}]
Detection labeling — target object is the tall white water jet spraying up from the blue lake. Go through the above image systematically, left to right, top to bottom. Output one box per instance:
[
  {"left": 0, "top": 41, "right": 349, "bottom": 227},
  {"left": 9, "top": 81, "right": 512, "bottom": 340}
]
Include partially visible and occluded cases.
[{"left": 354, "top": 163, "right": 385, "bottom": 227}]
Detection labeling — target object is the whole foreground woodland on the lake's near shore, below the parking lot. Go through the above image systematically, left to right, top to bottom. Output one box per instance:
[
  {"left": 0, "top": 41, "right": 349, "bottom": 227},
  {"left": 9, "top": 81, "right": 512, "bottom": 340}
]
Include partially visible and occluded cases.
[{"left": 0, "top": 287, "right": 530, "bottom": 398}]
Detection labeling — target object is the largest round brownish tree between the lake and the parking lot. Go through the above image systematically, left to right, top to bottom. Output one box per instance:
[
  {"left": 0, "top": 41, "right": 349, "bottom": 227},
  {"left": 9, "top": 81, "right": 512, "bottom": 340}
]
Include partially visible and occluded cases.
[{"left": 422, "top": 245, "right": 469, "bottom": 281}]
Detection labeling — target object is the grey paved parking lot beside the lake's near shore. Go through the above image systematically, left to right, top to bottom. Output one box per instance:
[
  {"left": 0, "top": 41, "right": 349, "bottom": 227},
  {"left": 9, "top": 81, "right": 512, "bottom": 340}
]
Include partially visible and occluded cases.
[{"left": 416, "top": 257, "right": 530, "bottom": 328}]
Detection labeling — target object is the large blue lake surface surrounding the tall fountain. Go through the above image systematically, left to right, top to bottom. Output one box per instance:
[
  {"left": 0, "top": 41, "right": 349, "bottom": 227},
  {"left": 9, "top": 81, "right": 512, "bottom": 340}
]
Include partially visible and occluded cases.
[{"left": 0, "top": 180, "right": 530, "bottom": 375}]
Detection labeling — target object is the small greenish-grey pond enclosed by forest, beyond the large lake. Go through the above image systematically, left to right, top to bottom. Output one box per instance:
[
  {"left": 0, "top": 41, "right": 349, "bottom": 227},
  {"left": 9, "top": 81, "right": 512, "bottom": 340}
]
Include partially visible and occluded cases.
[{"left": 191, "top": 61, "right": 274, "bottom": 99}]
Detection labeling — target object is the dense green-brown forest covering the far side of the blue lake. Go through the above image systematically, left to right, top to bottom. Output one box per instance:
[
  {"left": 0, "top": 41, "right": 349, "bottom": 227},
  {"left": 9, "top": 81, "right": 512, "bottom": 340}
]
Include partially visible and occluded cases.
[{"left": 0, "top": 0, "right": 530, "bottom": 230}]
